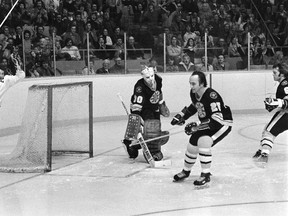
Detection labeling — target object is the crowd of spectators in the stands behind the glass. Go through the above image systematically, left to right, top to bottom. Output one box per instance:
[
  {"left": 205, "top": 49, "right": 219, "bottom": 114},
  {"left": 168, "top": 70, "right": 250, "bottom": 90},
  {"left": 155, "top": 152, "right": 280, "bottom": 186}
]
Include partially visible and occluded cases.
[{"left": 0, "top": 0, "right": 288, "bottom": 77}]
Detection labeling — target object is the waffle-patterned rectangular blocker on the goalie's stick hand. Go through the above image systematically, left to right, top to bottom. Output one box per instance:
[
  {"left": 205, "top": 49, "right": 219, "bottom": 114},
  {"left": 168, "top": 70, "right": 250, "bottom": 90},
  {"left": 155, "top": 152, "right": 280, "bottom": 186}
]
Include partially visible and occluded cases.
[{"left": 124, "top": 114, "right": 141, "bottom": 140}]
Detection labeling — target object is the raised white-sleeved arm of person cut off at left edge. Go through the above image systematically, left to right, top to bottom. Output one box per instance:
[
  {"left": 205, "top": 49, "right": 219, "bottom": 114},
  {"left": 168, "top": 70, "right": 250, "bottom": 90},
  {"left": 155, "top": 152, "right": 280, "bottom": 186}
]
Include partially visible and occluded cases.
[{"left": 0, "top": 54, "right": 25, "bottom": 106}]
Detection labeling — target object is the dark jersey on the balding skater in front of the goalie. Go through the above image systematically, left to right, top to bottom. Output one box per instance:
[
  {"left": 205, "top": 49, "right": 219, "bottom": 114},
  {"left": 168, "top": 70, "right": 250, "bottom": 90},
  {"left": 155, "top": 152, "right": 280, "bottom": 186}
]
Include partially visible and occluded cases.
[{"left": 188, "top": 88, "right": 233, "bottom": 130}]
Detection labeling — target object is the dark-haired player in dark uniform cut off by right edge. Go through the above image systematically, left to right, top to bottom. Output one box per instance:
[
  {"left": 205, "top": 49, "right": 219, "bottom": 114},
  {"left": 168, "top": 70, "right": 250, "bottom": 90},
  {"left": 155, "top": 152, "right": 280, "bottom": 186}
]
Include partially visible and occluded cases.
[{"left": 253, "top": 63, "right": 288, "bottom": 164}]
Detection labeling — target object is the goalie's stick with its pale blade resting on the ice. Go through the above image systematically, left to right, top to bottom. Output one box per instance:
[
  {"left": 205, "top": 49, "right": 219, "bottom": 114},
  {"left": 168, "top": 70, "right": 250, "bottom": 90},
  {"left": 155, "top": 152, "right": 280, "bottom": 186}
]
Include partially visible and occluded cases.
[{"left": 117, "top": 93, "right": 172, "bottom": 168}]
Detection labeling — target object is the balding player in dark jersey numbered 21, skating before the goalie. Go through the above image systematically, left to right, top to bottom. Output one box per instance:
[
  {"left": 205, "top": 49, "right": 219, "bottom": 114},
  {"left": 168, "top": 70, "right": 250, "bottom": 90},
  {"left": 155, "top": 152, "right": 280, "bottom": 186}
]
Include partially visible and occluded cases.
[{"left": 171, "top": 71, "right": 233, "bottom": 187}]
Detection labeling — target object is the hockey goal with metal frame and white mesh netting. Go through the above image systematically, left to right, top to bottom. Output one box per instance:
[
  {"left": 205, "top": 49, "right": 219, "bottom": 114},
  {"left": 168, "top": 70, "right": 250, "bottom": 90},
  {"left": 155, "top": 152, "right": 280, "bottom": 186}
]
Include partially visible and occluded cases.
[{"left": 0, "top": 82, "right": 93, "bottom": 172}]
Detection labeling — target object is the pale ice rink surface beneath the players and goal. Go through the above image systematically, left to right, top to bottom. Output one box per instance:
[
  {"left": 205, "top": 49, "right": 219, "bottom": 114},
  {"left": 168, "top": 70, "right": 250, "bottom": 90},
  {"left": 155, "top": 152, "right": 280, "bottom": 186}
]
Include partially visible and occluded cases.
[{"left": 0, "top": 112, "right": 288, "bottom": 216}]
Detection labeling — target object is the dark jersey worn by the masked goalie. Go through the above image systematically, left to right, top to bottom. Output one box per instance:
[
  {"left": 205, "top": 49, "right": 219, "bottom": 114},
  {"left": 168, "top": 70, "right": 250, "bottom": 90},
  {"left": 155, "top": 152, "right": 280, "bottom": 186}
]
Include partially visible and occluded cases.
[{"left": 130, "top": 74, "right": 162, "bottom": 116}]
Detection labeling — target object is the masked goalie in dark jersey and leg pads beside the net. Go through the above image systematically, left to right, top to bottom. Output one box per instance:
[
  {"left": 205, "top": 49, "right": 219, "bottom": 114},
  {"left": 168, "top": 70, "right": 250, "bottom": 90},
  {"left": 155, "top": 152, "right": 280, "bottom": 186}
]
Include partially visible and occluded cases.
[{"left": 124, "top": 65, "right": 170, "bottom": 161}]
